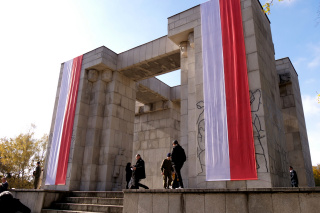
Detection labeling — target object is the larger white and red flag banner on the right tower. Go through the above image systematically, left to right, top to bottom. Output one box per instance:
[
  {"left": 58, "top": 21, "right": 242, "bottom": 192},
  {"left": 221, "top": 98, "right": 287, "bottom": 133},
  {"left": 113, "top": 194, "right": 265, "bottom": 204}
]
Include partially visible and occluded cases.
[{"left": 201, "top": 0, "right": 257, "bottom": 181}]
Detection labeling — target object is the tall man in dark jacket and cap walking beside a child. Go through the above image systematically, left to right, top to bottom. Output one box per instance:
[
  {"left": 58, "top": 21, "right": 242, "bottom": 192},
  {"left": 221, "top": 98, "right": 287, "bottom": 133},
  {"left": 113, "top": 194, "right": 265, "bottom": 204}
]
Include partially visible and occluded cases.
[{"left": 171, "top": 140, "right": 186, "bottom": 189}]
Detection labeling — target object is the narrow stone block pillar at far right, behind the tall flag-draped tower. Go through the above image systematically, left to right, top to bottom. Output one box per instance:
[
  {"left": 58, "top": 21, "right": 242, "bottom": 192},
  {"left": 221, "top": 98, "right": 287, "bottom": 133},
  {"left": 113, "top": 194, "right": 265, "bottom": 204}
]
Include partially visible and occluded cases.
[{"left": 276, "top": 58, "right": 314, "bottom": 187}]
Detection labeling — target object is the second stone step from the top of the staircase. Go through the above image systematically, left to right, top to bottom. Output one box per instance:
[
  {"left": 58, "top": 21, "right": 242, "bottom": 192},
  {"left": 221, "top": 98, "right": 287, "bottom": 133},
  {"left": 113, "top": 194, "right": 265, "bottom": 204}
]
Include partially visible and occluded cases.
[{"left": 63, "top": 197, "right": 123, "bottom": 206}]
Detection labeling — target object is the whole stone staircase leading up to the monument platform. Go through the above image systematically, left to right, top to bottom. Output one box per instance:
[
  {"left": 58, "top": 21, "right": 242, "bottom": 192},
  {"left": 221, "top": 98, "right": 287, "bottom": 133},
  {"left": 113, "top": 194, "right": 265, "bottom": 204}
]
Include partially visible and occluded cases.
[{"left": 41, "top": 191, "right": 123, "bottom": 213}]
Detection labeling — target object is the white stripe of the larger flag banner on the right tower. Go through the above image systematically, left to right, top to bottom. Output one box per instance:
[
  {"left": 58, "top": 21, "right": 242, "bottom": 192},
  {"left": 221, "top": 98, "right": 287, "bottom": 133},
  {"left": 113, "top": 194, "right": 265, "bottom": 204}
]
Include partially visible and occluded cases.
[{"left": 201, "top": 0, "right": 230, "bottom": 181}]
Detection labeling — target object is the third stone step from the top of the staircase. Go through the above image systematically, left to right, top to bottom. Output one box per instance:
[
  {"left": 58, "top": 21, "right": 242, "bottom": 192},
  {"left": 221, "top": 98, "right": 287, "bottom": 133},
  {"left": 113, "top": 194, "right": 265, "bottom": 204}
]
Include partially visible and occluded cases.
[{"left": 54, "top": 203, "right": 123, "bottom": 213}]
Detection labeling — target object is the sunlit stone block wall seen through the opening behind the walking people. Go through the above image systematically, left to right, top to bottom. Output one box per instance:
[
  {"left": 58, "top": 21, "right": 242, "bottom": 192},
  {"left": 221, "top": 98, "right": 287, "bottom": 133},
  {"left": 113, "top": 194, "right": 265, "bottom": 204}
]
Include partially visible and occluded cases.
[{"left": 131, "top": 101, "right": 180, "bottom": 189}]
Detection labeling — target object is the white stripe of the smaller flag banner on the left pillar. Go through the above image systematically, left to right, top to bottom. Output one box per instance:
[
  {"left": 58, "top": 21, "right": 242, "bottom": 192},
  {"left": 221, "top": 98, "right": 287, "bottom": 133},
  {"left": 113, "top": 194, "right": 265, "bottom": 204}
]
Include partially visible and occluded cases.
[{"left": 45, "top": 60, "right": 73, "bottom": 185}]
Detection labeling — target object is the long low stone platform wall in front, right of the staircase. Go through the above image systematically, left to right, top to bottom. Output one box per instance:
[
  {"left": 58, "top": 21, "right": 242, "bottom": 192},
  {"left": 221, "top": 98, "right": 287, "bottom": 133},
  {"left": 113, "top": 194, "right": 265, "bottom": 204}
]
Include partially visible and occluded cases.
[{"left": 123, "top": 187, "right": 320, "bottom": 213}]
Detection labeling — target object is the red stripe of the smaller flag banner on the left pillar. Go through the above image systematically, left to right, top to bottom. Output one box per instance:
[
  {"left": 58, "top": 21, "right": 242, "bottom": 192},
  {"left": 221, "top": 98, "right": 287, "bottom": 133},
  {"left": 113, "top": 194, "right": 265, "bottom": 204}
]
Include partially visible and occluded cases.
[{"left": 55, "top": 55, "right": 82, "bottom": 185}]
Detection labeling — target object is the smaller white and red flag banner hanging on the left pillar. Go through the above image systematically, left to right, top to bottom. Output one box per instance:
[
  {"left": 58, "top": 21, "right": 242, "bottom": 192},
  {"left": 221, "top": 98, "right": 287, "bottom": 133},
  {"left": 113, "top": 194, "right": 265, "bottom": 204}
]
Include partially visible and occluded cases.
[{"left": 45, "top": 55, "right": 82, "bottom": 185}]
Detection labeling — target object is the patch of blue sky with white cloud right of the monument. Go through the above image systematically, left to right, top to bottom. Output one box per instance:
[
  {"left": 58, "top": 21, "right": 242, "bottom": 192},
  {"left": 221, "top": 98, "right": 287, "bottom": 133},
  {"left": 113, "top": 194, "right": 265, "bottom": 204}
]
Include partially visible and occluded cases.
[{"left": 269, "top": 0, "right": 320, "bottom": 165}]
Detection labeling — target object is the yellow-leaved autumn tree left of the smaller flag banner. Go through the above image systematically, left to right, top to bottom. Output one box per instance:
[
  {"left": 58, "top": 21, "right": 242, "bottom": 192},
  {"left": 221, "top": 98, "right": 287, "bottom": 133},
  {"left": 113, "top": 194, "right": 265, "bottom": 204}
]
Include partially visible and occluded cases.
[{"left": 0, "top": 125, "right": 48, "bottom": 188}]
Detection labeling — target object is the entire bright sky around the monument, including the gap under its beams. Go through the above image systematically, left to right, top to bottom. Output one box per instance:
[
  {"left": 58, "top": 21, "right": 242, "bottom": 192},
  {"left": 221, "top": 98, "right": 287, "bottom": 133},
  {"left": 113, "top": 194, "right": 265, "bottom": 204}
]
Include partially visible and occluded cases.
[{"left": 0, "top": 0, "right": 320, "bottom": 165}]
